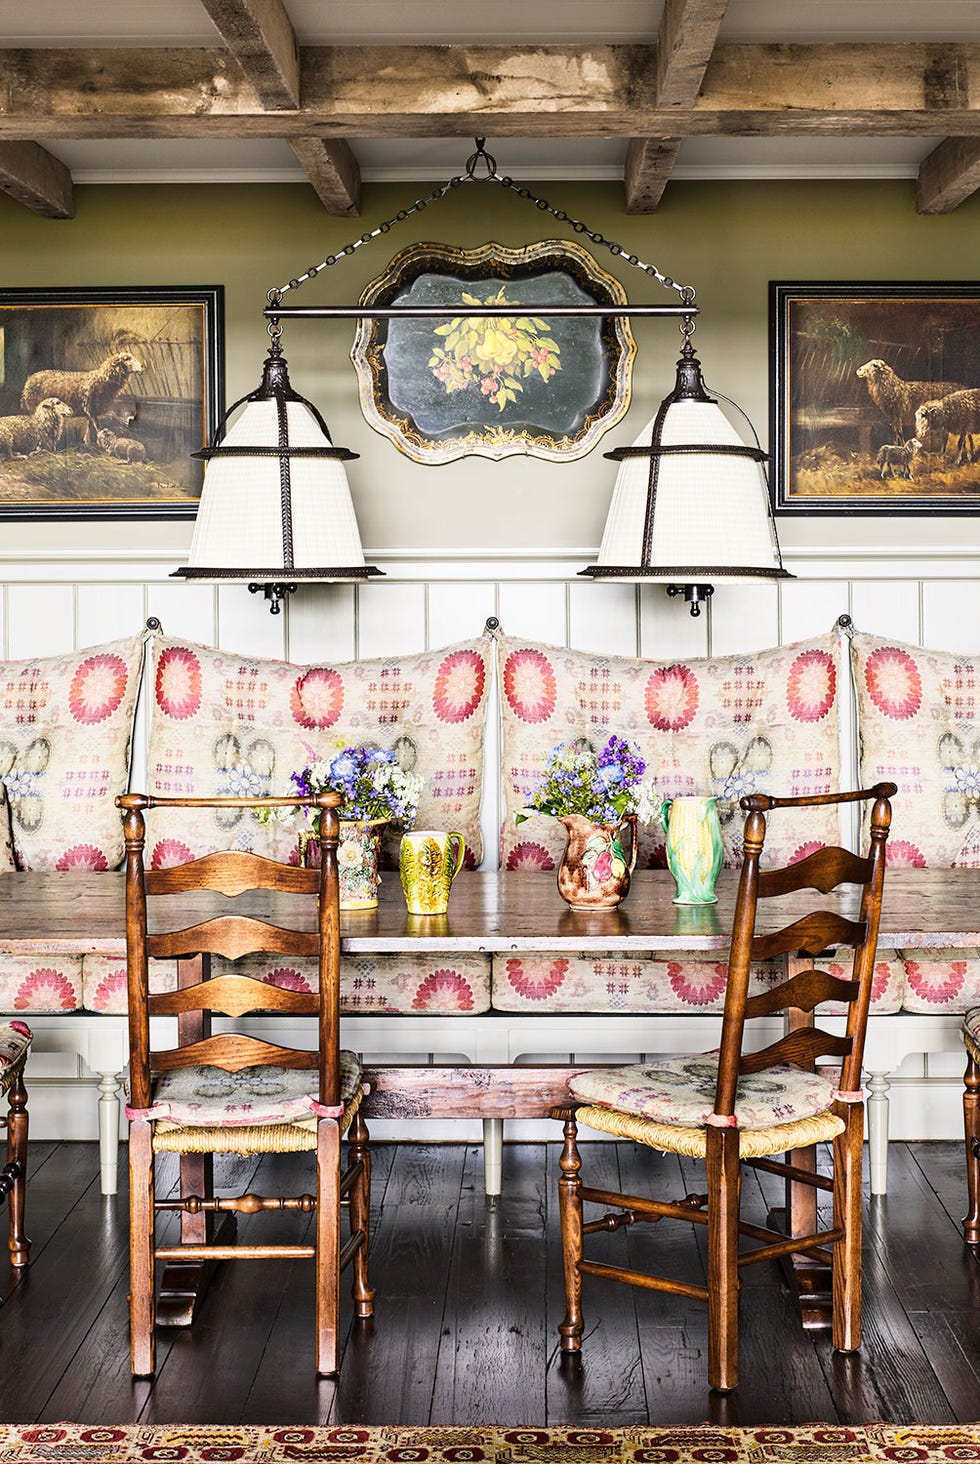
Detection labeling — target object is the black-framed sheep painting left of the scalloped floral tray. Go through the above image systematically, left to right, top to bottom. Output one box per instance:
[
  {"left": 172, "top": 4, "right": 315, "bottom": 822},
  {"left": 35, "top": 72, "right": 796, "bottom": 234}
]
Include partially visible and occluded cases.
[{"left": 0, "top": 285, "right": 224, "bottom": 518}]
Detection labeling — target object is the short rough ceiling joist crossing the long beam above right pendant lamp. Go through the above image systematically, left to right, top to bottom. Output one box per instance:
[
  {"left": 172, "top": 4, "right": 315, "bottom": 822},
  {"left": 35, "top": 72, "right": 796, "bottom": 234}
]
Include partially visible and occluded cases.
[{"left": 624, "top": 0, "right": 728, "bottom": 214}]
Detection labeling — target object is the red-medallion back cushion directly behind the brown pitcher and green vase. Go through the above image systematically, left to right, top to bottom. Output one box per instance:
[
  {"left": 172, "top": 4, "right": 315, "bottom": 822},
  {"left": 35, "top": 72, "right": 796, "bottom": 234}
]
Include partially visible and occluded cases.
[{"left": 498, "top": 635, "right": 841, "bottom": 870}]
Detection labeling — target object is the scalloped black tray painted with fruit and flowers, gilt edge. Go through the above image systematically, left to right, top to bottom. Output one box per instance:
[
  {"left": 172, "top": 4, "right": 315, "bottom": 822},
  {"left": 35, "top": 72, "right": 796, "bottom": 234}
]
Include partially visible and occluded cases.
[{"left": 350, "top": 240, "right": 636, "bottom": 464}]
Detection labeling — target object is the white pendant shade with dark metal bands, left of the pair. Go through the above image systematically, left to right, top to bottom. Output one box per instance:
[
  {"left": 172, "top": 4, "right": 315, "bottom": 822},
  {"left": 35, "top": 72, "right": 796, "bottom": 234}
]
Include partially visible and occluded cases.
[{"left": 174, "top": 322, "right": 382, "bottom": 615}]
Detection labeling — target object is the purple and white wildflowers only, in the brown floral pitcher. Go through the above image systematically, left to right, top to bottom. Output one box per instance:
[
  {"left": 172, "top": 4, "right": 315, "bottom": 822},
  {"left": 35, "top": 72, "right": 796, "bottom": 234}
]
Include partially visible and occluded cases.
[{"left": 514, "top": 735, "right": 661, "bottom": 824}]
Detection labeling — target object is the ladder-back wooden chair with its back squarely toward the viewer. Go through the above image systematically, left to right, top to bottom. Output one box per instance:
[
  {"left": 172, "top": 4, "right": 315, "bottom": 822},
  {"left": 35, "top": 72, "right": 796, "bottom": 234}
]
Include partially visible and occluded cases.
[{"left": 116, "top": 793, "right": 374, "bottom": 1376}]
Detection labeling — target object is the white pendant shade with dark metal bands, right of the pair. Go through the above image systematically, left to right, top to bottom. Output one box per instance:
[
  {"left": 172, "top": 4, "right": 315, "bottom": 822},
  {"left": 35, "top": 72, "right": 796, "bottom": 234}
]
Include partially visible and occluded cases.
[{"left": 580, "top": 318, "right": 794, "bottom": 615}]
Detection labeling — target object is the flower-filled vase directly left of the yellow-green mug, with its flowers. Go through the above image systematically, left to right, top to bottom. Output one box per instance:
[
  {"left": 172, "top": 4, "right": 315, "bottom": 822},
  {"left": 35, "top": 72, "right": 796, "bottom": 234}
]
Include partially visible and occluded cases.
[{"left": 262, "top": 747, "right": 422, "bottom": 911}]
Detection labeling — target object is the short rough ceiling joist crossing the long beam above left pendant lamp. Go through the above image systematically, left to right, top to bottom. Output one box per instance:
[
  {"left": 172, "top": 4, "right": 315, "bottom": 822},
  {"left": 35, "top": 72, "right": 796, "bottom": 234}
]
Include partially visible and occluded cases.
[{"left": 194, "top": 0, "right": 360, "bottom": 218}]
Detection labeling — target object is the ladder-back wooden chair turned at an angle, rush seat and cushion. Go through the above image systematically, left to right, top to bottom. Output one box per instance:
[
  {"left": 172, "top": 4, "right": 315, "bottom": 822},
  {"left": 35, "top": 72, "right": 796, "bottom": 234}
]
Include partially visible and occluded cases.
[{"left": 552, "top": 783, "right": 895, "bottom": 1391}]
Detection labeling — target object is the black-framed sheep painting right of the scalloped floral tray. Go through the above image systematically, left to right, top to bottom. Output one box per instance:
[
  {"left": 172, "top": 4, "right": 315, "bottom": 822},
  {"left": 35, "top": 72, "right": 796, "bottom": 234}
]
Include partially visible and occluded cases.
[{"left": 769, "top": 281, "right": 980, "bottom": 514}]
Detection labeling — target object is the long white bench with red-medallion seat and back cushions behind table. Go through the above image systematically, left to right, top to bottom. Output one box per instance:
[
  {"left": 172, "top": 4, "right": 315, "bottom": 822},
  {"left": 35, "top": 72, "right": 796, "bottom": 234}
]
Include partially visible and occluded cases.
[{"left": 0, "top": 624, "right": 980, "bottom": 1189}]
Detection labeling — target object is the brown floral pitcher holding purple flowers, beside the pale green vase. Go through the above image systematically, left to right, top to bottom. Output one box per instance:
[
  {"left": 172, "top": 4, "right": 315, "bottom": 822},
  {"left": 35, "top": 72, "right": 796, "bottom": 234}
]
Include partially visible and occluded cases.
[{"left": 516, "top": 735, "right": 661, "bottom": 911}]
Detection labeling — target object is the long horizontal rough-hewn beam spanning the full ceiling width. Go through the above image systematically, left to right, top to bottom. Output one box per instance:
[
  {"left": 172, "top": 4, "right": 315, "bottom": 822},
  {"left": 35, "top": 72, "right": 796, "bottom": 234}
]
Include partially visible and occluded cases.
[{"left": 0, "top": 42, "right": 980, "bottom": 139}]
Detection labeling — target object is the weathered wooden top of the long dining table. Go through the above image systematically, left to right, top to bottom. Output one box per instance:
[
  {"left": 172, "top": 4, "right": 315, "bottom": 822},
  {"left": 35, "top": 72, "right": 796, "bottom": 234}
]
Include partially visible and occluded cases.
[{"left": 0, "top": 870, "right": 980, "bottom": 956}]
